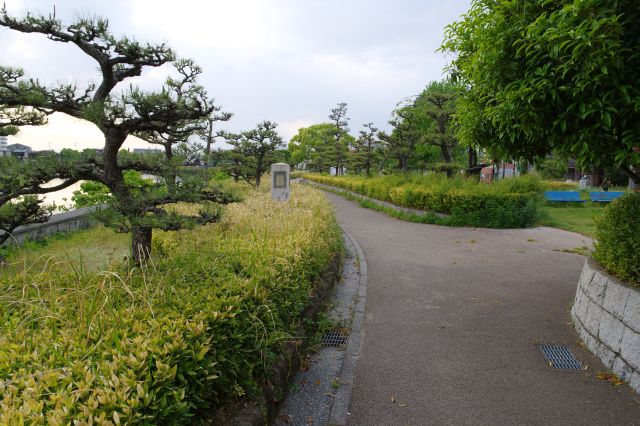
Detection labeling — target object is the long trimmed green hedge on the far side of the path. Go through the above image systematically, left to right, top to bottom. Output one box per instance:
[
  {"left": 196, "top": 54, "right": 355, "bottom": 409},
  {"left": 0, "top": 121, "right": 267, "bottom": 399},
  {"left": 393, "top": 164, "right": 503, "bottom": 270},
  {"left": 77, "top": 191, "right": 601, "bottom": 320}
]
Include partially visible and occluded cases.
[{"left": 305, "top": 174, "right": 544, "bottom": 228}]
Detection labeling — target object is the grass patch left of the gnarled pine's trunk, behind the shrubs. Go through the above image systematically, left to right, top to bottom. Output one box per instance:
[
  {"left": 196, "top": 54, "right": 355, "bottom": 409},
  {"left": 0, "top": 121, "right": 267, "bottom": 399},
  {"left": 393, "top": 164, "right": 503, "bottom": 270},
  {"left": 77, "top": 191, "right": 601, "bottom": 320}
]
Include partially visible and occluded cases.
[{"left": 0, "top": 225, "right": 131, "bottom": 278}]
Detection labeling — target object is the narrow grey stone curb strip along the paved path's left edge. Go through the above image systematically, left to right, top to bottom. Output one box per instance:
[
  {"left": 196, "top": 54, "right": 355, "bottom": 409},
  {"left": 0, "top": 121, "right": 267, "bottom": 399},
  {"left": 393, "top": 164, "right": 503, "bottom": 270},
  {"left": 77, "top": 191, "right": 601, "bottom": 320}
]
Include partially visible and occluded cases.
[{"left": 328, "top": 227, "right": 368, "bottom": 426}]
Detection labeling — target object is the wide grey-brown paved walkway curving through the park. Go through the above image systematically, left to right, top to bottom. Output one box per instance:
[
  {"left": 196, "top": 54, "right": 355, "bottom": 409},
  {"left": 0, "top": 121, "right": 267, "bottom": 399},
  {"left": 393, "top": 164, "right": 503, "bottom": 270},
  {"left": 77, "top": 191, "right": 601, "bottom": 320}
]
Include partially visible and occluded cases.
[{"left": 327, "top": 194, "right": 640, "bottom": 425}]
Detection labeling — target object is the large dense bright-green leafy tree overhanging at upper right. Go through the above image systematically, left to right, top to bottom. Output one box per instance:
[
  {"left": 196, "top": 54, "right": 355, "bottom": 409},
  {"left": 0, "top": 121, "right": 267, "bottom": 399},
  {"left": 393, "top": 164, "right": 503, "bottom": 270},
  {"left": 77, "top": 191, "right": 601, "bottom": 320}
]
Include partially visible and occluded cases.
[{"left": 442, "top": 0, "right": 640, "bottom": 182}]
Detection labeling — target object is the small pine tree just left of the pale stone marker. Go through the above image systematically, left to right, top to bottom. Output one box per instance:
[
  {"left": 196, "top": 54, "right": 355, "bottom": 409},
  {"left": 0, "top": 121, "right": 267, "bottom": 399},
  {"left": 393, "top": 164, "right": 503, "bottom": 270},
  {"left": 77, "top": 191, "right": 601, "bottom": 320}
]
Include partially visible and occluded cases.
[{"left": 225, "top": 121, "right": 282, "bottom": 187}]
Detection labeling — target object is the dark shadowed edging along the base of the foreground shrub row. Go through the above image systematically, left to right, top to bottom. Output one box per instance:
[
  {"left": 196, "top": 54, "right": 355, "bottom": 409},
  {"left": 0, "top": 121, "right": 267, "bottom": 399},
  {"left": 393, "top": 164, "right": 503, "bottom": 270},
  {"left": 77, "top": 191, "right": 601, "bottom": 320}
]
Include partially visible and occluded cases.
[{"left": 228, "top": 254, "right": 342, "bottom": 426}]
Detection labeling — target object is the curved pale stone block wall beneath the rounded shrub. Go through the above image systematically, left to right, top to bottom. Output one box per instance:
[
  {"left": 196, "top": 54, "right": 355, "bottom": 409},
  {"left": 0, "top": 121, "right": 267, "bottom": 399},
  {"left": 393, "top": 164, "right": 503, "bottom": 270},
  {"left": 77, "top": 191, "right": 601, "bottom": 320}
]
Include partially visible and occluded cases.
[{"left": 571, "top": 258, "right": 640, "bottom": 392}]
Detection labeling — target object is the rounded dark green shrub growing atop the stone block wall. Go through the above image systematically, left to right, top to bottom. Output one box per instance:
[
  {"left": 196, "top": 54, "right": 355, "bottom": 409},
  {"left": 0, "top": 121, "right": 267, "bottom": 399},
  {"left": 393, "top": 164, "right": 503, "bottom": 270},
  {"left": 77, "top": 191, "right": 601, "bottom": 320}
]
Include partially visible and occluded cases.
[{"left": 593, "top": 193, "right": 640, "bottom": 284}]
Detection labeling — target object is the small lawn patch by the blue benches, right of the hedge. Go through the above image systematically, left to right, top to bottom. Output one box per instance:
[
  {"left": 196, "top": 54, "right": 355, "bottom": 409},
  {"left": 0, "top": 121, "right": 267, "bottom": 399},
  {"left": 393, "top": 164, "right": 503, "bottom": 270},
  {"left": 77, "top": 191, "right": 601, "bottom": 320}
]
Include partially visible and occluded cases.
[{"left": 540, "top": 203, "right": 606, "bottom": 237}]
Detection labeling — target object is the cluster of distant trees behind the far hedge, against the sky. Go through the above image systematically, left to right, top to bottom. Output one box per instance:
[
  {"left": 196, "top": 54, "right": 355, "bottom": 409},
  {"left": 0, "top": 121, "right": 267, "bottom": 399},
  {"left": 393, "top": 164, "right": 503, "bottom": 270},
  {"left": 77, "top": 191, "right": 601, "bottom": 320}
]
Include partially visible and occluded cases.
[{"left": 289, "top": 90, "right": 462, "bottom": 175}]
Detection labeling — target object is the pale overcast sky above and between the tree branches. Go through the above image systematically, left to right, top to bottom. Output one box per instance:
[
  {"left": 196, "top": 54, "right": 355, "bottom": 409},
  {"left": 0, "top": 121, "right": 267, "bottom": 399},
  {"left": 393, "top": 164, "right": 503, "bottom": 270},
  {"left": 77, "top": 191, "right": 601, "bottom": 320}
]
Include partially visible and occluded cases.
[{"left": 0, "top": 0, "right": 470, "bottom": 150}]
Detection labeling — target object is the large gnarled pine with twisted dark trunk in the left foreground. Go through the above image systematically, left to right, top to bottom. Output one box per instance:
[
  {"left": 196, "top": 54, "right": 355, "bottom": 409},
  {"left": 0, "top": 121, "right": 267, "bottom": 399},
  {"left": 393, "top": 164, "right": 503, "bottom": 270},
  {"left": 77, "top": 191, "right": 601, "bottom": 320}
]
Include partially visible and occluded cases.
[{"left": 0, "top": 8, "right": 232, "bottom": 264}]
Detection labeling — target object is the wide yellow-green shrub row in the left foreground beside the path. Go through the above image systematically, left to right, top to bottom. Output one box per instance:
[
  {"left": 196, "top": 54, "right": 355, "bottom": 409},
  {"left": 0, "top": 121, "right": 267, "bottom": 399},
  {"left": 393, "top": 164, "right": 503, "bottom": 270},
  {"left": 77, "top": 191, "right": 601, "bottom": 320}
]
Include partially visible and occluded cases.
[{"left": 0, "top": 188, "right": 340, "bottom": 424}]
